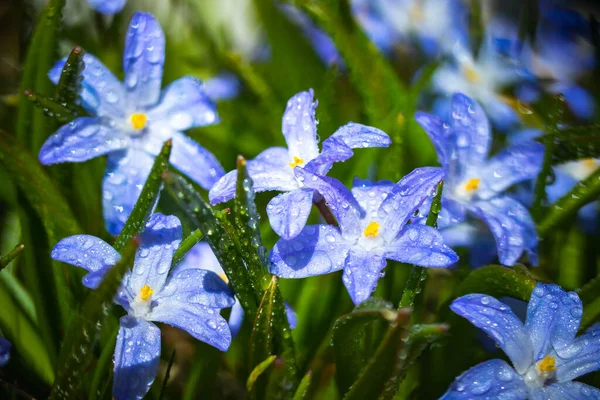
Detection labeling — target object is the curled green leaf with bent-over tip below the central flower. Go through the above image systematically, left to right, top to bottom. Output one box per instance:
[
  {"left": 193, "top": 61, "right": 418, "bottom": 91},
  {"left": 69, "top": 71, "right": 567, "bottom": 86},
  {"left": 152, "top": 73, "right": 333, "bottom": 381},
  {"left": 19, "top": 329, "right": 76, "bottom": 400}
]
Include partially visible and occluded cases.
[{"left": 333, "top": 297, "right": 397, "bottom": 393}]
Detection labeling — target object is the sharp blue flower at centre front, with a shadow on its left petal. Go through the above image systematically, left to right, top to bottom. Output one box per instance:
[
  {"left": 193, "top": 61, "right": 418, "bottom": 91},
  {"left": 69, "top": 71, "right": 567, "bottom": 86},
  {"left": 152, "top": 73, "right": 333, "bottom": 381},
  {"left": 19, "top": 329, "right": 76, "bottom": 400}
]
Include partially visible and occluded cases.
[{"left": 270, "top": 168, "right": 458, "bottom": 304}]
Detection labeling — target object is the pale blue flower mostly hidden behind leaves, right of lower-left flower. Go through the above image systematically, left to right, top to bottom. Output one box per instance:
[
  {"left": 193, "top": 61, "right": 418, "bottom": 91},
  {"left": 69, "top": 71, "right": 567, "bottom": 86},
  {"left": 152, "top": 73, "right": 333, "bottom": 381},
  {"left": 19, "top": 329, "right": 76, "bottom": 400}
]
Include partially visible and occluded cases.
[{"left": 175, "top": 242, "right": 297, "bottom": 337}]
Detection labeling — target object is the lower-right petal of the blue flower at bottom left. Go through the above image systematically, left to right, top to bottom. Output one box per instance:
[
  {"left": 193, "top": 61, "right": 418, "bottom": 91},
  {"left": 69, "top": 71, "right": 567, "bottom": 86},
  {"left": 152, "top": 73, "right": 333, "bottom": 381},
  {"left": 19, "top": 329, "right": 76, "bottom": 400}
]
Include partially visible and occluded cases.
[{"left": 148, "top": 302, "right": 231, "bottom": 351}]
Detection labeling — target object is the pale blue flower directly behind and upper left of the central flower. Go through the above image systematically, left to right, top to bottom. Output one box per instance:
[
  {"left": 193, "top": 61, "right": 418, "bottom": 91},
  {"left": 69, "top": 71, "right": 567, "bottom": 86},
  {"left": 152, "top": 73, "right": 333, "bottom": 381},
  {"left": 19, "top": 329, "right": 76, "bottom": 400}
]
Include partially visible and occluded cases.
[{"left": 209, "top": 89, "right": 391, "bottom": 239}]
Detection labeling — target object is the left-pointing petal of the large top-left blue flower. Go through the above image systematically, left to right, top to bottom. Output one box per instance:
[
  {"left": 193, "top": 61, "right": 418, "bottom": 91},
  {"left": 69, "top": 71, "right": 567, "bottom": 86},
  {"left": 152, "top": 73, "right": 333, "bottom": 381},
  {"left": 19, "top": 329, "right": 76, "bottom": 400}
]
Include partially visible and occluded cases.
[{"left": 39, "top": 117, "right": 130, "bottom": 165}]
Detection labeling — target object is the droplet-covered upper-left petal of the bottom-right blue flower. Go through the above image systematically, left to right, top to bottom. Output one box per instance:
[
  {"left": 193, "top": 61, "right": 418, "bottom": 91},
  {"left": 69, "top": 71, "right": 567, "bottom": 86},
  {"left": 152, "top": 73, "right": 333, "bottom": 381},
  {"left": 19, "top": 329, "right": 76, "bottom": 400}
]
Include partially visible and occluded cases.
[{"left": 450, "top": 294, "right": 533, "bottom": 374}]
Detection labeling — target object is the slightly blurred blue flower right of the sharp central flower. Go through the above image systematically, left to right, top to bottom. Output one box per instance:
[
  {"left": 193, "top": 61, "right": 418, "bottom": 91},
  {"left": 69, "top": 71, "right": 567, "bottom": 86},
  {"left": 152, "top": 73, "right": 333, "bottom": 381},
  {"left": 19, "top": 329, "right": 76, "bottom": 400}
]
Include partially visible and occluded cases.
[{"left": 415, "top": 94, "right": 544, "bottom": 265}]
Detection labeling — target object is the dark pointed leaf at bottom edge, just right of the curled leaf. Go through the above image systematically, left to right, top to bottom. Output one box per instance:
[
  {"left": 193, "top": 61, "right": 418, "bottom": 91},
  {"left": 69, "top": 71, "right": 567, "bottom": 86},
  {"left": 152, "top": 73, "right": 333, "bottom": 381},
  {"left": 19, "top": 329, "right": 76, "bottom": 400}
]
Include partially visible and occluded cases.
[{"left": 344, "top": 309, "right": 410, "bottom": 400}]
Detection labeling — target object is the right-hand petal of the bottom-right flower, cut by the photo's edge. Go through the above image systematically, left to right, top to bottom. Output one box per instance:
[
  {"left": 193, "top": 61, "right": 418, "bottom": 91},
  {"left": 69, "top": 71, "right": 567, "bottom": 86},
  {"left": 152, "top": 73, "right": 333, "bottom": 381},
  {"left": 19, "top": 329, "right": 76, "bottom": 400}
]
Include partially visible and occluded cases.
[{"left": 556, "top": 322, "right": 600, "bottom": 382}]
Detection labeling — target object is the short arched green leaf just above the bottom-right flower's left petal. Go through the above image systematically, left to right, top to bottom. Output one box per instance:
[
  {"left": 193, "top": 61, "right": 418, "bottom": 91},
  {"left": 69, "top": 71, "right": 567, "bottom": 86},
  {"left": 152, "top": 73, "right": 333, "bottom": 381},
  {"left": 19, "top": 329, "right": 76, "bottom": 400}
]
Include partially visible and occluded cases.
[{"left": 458, "top": 265, "right": 536, "bottom": 301}]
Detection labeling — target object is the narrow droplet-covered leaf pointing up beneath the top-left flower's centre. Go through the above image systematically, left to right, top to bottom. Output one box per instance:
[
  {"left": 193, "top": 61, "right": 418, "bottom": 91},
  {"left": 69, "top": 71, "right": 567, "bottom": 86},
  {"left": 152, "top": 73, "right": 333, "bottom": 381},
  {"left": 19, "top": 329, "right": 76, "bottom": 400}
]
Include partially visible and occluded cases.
[{"left": 113, "top": 139, "right": 173, "bottom": 251}]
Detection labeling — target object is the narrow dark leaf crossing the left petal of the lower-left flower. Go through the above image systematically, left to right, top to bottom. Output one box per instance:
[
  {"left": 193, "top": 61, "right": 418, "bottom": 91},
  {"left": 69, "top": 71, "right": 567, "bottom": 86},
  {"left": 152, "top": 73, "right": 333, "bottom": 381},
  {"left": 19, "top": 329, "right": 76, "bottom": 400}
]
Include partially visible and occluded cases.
[{"left": 50, "top": 241, "right": 139, "bottom": 399}]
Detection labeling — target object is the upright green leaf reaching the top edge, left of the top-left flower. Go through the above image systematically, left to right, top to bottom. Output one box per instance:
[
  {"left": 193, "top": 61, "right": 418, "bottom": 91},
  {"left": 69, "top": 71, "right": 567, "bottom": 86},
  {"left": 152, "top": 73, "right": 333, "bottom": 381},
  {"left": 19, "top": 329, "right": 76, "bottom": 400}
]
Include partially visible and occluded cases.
[{"left": 16, "top": 0, "right": 65, "bottom": 152}]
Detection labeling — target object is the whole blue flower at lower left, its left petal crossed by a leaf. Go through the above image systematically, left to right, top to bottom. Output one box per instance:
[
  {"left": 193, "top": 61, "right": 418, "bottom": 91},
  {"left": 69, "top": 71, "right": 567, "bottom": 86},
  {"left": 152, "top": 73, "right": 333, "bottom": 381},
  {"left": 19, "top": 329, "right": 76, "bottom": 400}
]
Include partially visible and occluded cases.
[{"left": 52, "top": 213, "right": 235, "bottom": 400}]
